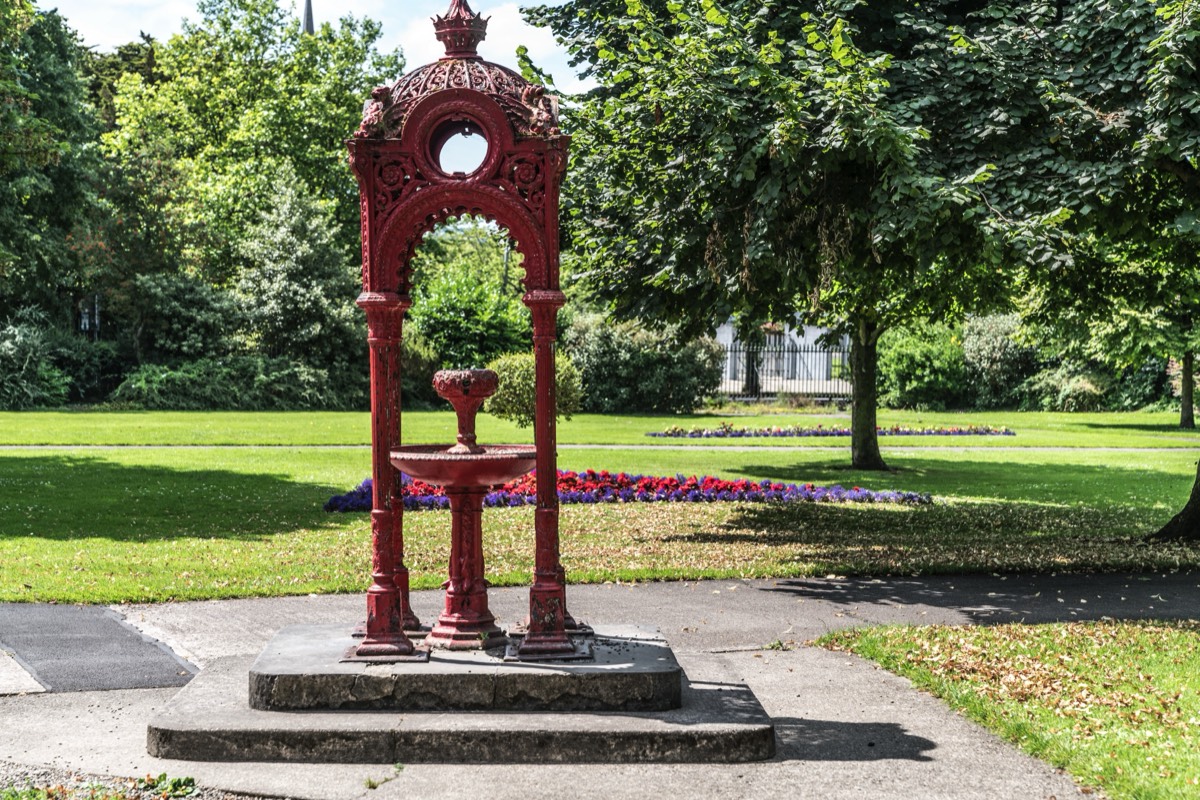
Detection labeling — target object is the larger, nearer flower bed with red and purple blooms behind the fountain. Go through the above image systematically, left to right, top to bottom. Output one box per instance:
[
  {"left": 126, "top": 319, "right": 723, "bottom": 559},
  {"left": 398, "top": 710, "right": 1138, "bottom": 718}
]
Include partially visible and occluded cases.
[{"left": 325, "top": 469, "right": 934, "bottom": 511}]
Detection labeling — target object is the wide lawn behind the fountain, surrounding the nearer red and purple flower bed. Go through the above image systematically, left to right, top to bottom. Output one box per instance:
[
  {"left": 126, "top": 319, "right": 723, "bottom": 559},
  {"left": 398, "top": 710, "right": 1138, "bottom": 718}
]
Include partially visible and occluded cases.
[{"left": 0, "top": 447, "right": 1200, "bottom": 602}]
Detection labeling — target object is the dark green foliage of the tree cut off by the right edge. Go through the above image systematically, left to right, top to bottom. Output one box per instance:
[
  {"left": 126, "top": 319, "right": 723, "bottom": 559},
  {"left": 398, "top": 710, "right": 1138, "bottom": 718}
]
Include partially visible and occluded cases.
[{"left": 1025, "top": 0, "right": 1200, "bottom": 428}]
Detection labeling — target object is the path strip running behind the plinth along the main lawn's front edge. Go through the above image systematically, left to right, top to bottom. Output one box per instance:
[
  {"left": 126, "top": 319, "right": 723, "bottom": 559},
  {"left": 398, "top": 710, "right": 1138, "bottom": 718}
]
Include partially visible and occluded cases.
[{"left": 115, "top": 572, "right": 1200, "bottom": 666}]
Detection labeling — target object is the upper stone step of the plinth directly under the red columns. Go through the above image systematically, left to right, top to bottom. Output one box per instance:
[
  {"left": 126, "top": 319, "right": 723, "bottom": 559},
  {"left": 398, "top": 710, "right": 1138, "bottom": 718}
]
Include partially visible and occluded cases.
[{"left": 250, "top": 624, "right": 683, "bottom": 711}]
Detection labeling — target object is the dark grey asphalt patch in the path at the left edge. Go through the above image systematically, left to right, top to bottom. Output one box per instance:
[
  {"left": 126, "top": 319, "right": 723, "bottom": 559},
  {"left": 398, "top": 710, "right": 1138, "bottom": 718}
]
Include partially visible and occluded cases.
[{"left": 0, "top": 603, "right": 196, "bottom": 692}]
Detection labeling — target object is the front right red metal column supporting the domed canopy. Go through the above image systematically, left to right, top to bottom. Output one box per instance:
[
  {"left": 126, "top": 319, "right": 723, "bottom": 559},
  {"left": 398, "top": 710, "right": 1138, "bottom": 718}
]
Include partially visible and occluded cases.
[{"left": 518, "top": 289, "right": 575, "bottom": 656}]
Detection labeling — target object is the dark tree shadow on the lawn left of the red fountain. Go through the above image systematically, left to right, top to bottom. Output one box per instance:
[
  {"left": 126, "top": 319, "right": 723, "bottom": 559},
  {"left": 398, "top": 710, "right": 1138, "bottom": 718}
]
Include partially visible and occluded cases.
[{"left": 0, "top": 453, "right": 344, "bottom": 542}]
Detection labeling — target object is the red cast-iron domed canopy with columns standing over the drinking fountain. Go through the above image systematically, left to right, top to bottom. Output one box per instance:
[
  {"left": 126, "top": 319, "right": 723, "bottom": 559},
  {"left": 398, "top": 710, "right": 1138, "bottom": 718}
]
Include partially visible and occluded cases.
[{"left": 347, "top": 0, "right": 576, "bottom": 660}]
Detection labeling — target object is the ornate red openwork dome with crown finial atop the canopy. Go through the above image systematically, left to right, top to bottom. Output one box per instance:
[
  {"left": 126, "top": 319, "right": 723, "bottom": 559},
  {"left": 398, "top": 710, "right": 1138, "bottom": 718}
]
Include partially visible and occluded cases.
[{"left": 354, "top": 0, "right": 559, "bottom": 139}]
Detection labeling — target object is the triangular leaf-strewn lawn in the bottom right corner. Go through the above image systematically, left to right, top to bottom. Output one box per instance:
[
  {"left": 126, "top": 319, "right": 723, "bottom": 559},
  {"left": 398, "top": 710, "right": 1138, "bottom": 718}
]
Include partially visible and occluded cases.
[{"left": 821, "top": 620, "right": 1200, "bottom": 800}]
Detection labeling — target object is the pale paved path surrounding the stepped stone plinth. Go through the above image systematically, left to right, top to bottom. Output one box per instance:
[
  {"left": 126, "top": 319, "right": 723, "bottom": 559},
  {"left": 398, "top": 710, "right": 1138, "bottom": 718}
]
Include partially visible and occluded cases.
[{"left": 0, "top": 573, "right": 1200, "bottom": 800}]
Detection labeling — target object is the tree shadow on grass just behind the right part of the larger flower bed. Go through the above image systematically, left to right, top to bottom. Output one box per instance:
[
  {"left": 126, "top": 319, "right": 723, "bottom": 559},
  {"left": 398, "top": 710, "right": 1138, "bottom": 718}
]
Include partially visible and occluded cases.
[{"left": 730, "top": 453, "right": 1194, "bottom": 506}]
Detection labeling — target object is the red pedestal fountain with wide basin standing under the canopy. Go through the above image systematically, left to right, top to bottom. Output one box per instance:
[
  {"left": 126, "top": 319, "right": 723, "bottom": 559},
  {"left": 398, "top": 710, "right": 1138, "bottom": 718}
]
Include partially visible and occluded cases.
[{"left": 391, "top": 369, "right": 536, "bottom": 650}]
